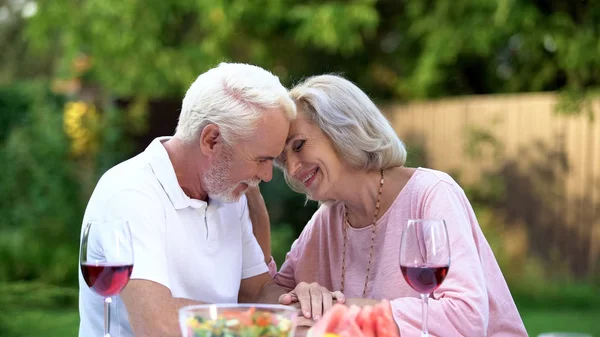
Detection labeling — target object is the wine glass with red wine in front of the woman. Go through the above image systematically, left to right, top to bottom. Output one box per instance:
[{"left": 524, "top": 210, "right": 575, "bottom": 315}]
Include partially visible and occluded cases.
[{"left": 400, "top": 219, "right": 450, "bottom": 337}]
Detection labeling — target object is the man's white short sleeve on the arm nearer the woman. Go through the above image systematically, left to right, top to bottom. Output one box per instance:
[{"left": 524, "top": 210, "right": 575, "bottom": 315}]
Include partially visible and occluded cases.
[{"left": 238, "top": 196, "right": 269, "bottom": 279}]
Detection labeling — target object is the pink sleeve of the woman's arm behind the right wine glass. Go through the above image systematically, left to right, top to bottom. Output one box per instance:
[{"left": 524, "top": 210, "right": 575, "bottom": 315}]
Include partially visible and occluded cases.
[{"left": 391, "top": 181, "right": 489, "bottom": 337}]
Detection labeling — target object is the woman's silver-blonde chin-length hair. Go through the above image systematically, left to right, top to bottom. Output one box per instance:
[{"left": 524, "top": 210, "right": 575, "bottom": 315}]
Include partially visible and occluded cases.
[{"left": 276, "top": 75, "right": 406, "bottom": 186}]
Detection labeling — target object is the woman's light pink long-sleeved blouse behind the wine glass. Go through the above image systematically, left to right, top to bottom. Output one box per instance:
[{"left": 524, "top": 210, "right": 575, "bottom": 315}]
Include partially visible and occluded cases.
[{"left": 270, "top": 168, "right": 527, "bottom": 337}]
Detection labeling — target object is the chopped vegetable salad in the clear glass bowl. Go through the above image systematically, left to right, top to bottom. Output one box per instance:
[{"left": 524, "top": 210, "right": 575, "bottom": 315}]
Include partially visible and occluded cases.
[{"left": 185, "top": 307, "right": 293, "bottom": 337}]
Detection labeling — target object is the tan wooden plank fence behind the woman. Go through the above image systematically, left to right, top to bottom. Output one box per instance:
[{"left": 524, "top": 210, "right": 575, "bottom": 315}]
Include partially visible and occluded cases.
[{"left": 382, "top": 93, "right": 600, "bottom": 280}]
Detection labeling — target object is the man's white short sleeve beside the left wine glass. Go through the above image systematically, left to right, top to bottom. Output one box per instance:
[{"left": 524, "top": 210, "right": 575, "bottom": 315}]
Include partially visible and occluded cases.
[{"left": 102, "top": 190, "right": 170, "bottom": 288}]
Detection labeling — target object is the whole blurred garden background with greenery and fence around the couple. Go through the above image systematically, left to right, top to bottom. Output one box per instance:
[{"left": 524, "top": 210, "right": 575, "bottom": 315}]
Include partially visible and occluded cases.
[{"left": 0, "top": 0, "right": 600, "bottom": 337}]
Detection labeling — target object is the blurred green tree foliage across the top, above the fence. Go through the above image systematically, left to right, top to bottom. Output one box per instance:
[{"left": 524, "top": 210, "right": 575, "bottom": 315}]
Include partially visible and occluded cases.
[{"left": 0, "top": 0, "right": 588, "bottom": 118}]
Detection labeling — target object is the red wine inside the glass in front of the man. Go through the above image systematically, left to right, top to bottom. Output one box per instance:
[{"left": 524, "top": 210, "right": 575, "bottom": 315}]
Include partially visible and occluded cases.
[{"left": 81, "top": 263, "right": 133, "bottom": 297}]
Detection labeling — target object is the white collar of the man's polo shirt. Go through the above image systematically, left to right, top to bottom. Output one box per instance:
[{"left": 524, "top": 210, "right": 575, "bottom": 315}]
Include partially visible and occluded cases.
[{"left": 144, "top": 137, "right": 222, "bottom": 210}]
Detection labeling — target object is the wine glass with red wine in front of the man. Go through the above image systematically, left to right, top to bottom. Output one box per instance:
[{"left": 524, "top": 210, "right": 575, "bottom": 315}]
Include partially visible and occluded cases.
[{"left": 79, "top": 220, "right": 133, "bottom": 337}]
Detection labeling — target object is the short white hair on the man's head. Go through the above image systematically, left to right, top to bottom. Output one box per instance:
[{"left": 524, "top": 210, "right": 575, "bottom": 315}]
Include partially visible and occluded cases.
[{"left": 175, "top": 63, "right": 296, "bottom": 145}]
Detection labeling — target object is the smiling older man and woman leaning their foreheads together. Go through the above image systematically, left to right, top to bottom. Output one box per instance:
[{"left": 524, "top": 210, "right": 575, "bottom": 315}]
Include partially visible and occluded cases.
[{"left": 79, "top": 63, "right": 527, "bottom": 337}]
